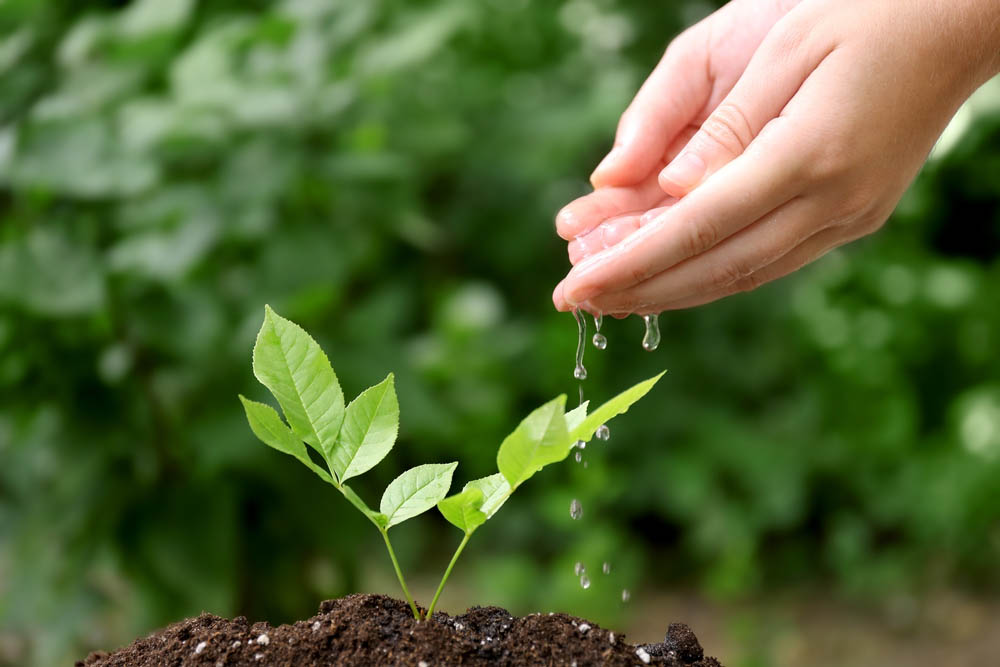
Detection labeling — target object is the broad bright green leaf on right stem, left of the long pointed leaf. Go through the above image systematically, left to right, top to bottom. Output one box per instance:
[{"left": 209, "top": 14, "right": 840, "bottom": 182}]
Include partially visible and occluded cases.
[{"left": 497, "top": 395, "right": 569, "bottom": 489}]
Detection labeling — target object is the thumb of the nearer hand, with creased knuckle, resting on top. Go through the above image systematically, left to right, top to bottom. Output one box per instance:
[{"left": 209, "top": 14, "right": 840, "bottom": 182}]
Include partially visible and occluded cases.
[{"left": 659, "top": 19, "right": 828, "bottom": 197}]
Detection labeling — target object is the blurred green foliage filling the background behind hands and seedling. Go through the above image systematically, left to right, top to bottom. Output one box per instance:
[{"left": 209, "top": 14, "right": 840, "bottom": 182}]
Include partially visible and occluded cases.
[{"left": 0, "top": 0, "right": 1000, "bottom": 665}]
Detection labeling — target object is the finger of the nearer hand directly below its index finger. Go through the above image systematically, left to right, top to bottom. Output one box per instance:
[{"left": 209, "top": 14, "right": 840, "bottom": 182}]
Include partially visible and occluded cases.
[{"left": 591, "top": 197, "right": 833, "bottom": 312}]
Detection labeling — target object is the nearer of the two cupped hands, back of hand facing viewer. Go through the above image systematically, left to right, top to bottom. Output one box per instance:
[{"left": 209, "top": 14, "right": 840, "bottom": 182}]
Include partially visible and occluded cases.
[{"left": 553, "top": 0, "right": 1000, "bottom": 314}]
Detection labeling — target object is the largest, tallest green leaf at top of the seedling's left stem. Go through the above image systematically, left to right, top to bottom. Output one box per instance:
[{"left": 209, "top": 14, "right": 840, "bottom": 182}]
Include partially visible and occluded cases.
[{"left": 253, "top": 306, "right": 344, "bottom": 460}]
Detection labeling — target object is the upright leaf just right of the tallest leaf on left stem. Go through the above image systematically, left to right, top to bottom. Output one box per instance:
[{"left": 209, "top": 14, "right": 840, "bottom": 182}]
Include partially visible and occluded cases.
[{"left": 329, "top": 373, "right": 399, "bottom": 482}]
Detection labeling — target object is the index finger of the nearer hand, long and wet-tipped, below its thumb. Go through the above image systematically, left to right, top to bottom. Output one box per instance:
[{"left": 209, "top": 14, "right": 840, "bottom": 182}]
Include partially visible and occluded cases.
[{"left": 563, "top": 119, "right": 806, "bottom": 303}]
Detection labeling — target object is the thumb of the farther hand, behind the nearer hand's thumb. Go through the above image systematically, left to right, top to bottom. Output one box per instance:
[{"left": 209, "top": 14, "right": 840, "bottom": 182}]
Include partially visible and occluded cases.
[{"left": 590, "top": 33, "right": 712, "bottom": 188}]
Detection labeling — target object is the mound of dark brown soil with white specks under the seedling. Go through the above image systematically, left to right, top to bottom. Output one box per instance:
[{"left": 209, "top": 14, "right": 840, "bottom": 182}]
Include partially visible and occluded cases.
[{"left": 76, "top": 595, "right": 721, "bottom": 667}]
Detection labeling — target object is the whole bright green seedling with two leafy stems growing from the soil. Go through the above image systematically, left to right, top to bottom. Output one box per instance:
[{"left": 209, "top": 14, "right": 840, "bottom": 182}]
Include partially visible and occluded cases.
[{"left": 240, "top": 306, "right": 663, "bottom": 620}]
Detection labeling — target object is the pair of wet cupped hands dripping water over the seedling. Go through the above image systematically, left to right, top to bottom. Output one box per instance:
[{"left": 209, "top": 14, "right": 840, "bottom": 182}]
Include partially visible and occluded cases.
[{"left": 553, "top": 0, "right": 1000, "bottom": 316}]
